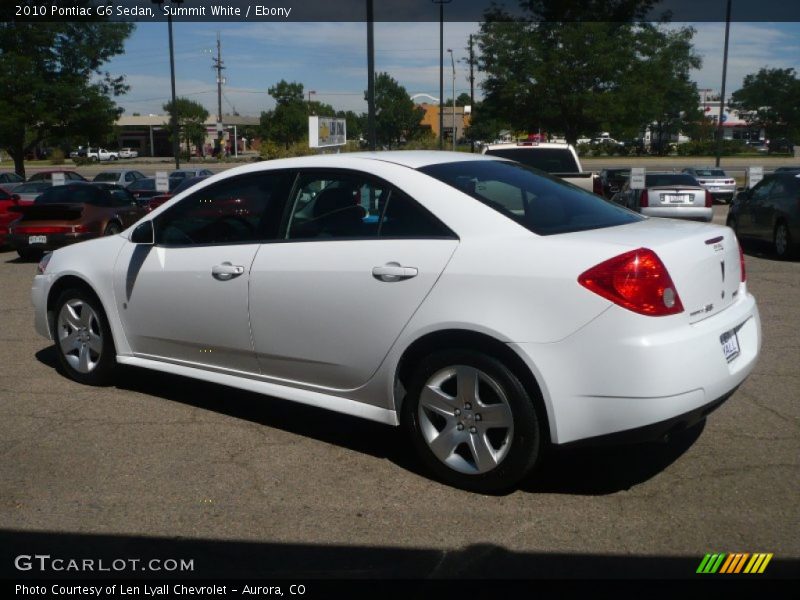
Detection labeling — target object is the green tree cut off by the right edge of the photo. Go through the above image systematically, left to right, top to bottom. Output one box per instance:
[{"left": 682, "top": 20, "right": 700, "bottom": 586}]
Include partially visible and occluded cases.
[{"left": 731, "top": 67, "right": 800, "bottom": 140}]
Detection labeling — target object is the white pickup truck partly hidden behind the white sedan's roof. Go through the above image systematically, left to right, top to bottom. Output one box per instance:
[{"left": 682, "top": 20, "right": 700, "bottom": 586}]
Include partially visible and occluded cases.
[{"left": 483, "top": 142, "right": 603, "bottom": 196}]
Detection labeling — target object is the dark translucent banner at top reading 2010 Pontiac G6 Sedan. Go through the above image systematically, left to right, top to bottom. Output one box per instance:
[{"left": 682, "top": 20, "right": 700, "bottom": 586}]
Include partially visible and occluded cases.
[{"left": 0, "top": 0, "right": 800, "bottom": 23}]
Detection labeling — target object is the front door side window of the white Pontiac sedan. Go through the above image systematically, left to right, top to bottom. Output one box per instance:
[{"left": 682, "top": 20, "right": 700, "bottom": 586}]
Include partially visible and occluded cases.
[{"left": 156, "top": 171, "right": 287, "bottom": 246}]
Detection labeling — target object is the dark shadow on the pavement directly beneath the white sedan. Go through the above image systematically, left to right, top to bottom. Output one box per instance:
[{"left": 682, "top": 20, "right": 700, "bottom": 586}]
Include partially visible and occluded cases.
[{"left": 36, "top": 346, "right": 704, "bottom": 496}]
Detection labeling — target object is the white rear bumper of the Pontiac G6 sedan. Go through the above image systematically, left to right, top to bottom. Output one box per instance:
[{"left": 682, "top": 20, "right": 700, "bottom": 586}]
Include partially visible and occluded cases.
[{"left": 511, "top": 288, "right": 761, "bottom": 444}]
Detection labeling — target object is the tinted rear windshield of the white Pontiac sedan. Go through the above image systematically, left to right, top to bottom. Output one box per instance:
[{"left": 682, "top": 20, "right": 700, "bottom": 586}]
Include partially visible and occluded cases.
[{"left": 419, "top": 160, "right": 644, "bottom": 235}]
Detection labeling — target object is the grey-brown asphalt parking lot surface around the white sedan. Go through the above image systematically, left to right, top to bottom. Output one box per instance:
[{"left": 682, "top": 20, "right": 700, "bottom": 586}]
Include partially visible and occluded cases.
[{"left": 0, "top": 205, "right": 800, "bottom": 578}]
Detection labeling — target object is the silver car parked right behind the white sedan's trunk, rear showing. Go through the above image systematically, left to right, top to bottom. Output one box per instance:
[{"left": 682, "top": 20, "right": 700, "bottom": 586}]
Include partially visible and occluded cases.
[{"left": 611, "top": 173, "right": 714, "bottom": 222}]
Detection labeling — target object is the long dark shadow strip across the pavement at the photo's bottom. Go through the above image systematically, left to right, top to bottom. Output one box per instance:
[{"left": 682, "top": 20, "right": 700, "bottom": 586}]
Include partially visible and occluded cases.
[{"left": 0, "top": 529, "right": 800, "bottom": 580}]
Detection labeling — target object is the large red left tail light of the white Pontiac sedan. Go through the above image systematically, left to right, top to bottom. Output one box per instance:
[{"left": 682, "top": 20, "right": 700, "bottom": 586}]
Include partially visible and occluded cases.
[{"left": 578, "top": 248, "right": 683, "bottom": 317}]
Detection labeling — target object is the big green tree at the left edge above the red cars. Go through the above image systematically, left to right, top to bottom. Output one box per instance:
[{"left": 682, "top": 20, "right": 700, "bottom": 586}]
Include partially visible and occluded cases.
[{"left": 0, "top": 5, "right": 133, "bottom": 176}]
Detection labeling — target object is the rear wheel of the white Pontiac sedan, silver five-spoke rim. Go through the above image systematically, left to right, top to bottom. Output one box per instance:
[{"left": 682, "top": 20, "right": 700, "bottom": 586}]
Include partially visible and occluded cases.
[{"left": 401, "top": 349, "right": 544, "bottom": 493}]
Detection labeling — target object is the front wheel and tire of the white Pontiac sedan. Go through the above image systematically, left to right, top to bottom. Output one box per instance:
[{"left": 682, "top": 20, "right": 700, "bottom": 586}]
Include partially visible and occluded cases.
[{"left": 53, "top": 288, "right": 116, "bottom": 385}]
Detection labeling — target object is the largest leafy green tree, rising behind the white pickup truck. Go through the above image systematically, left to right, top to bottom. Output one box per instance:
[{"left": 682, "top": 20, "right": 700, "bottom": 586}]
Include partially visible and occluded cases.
[{"left": 476, "top": 0, "right": 700, "bottom": 143}]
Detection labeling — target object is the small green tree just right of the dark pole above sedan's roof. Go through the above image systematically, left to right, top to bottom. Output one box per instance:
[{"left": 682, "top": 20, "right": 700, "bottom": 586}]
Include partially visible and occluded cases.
[{"left": 364, "top": 73, "right": 425, "bottom": 148}]
